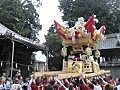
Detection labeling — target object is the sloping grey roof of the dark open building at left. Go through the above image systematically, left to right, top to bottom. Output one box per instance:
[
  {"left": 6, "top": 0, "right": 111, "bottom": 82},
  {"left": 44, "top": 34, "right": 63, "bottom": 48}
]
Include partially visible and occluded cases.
[{"left": 0, "top": 23, "right": 45, "bottom": 50}]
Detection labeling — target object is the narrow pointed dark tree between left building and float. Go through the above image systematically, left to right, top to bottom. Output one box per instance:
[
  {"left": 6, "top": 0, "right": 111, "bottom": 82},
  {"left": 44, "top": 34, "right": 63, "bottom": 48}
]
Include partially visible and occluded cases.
[{"left": 44, "top": 25, "right": 63, "bottom": 70}]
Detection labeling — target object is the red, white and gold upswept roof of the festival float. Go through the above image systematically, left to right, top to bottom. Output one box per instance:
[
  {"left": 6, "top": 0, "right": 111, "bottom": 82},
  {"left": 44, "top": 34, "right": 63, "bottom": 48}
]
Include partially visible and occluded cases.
[{"left": 54, "top": 15, "right": 105, "bottom": 49}]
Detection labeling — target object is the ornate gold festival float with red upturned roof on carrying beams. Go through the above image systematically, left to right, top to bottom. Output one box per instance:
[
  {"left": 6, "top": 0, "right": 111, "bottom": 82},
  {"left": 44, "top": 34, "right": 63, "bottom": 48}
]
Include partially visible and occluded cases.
[{"left": 35, "top": 15, "right": 109, "bottom": 79}]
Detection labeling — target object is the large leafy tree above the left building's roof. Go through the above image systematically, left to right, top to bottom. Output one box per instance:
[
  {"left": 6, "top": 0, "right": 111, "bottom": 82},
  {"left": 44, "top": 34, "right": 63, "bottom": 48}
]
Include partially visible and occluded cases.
[{"left": 0, "top": 0, "right": 41, "bottom": 40}]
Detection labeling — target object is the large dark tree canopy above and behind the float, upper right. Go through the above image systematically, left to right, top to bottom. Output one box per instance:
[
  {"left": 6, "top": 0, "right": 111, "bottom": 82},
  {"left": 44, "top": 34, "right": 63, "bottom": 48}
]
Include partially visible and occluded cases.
[{"left": 59, "top": 0, "right": 120, "bottom": 33}]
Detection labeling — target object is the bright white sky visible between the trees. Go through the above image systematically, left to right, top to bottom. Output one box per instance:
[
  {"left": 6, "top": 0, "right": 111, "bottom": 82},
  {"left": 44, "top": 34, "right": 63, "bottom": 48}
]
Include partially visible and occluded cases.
[{"left": 36, "top": 0, "right": 63, "bottom": 62}]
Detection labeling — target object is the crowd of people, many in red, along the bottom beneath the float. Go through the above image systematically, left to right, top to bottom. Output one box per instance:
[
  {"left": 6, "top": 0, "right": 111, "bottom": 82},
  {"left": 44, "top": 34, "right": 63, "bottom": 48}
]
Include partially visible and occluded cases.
[{"left": 0, "top": 75, "right": 120, "bottom": 90}]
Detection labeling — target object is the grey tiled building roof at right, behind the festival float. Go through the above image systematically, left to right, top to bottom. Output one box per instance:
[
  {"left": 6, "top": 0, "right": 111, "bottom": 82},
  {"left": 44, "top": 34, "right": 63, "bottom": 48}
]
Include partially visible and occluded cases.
[{"left": 96, "top": 33, "right": 120, "bottom": 49}]
